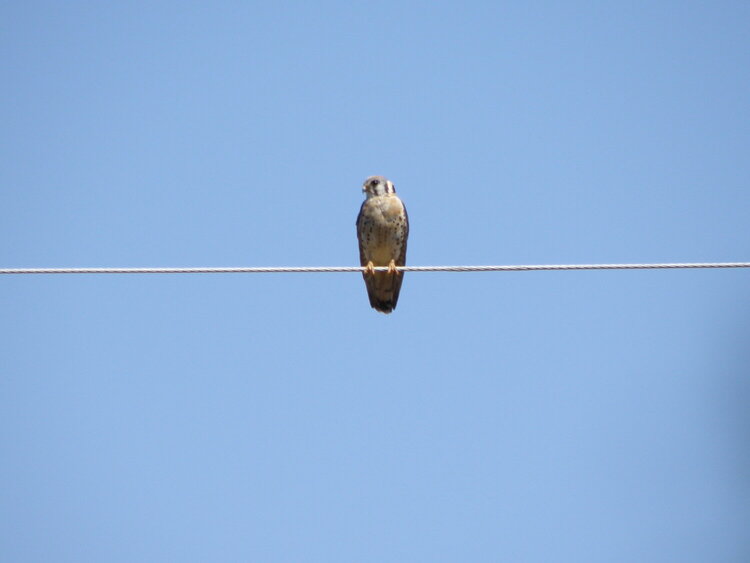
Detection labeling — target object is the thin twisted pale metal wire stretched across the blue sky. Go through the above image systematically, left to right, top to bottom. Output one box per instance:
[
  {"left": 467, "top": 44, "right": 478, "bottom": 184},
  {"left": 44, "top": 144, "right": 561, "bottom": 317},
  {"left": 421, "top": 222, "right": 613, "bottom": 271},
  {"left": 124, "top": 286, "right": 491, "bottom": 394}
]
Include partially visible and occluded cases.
[{"left": 0, "top": 262, "right": 750, "bottom": 274}]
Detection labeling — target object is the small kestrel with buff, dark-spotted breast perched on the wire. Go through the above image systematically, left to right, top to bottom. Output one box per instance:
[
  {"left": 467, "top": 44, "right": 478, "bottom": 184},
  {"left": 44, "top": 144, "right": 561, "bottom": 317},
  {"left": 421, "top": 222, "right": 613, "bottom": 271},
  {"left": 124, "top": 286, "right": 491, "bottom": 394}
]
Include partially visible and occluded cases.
[{"left": 357, "top": 176, "right": 409, "bottom": 313}]
